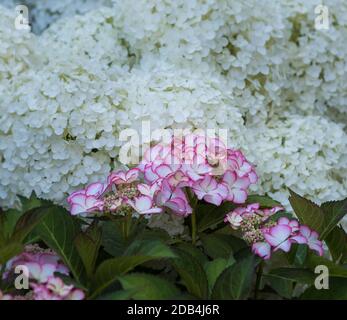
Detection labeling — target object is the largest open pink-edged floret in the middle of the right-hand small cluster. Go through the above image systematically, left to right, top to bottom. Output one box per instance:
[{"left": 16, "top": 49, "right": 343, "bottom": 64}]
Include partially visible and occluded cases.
[{"left": 263, "top": 224, "right": 292, "bottom": 252}]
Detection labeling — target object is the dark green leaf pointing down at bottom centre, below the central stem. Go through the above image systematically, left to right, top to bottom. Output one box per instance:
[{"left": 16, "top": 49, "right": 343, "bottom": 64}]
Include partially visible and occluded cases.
[{"left": 172, "top": 248, "right": 208, "bottom": 299}]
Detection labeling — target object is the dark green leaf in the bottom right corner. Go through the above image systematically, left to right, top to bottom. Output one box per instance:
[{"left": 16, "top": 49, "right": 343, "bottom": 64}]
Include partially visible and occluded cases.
[{"left": 300, "top": 277, "right": 347, "bottom": 300}]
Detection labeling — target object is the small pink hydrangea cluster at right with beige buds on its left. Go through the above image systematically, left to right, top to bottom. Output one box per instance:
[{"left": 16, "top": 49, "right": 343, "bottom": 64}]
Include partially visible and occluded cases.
[{"left": 224, "top": 203, "right": 323, "bottom": 260}]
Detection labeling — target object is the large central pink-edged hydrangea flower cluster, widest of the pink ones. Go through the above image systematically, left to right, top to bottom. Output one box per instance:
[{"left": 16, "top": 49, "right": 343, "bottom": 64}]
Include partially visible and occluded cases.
[{"left": 67, "top": 134, "right": 258, "bottom": 216}]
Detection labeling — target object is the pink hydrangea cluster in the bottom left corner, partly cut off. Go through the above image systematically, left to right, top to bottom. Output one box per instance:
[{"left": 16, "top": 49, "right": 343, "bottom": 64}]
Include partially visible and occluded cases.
[{"left": 3, "top": 246, "right": 84, "bottom": 300}]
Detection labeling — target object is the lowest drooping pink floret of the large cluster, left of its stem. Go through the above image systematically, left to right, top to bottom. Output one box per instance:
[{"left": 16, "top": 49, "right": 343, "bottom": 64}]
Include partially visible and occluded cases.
[{"left": 156, "top": 180, "right": 192, "bottom": 216}]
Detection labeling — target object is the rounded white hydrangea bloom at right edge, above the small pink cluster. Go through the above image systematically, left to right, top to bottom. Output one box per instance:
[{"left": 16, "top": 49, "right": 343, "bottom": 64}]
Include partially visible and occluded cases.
[{"left": 246, "top": 115, "right": 347, "bottom": 206}]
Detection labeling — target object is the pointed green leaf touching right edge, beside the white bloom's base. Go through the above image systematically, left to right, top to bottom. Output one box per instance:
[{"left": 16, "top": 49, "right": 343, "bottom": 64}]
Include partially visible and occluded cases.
[{"left": 320, "top": 199, "right": 347, "bottom": 239}]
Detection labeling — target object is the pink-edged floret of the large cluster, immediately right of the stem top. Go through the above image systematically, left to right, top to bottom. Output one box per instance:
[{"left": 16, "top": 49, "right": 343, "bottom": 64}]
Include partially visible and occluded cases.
[{"left": 192, "top": 176, "right": 228, "bottom": 206}]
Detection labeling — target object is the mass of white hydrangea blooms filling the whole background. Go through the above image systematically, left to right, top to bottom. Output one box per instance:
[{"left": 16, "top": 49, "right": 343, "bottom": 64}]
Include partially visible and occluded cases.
[{"left": 0, "top": 0, "right": 347, "bottom": 228}]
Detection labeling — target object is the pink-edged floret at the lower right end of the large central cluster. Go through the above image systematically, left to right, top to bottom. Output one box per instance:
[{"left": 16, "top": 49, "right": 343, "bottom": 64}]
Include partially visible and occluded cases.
[{"left": 222, "top": 170, "right": 251, "bottom": 203}]
